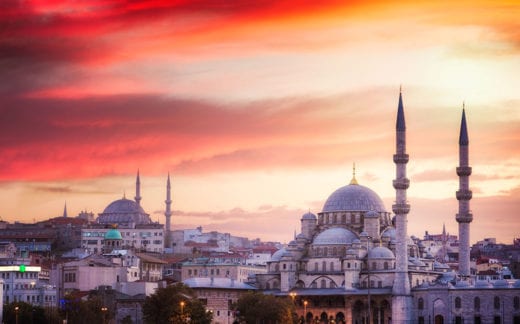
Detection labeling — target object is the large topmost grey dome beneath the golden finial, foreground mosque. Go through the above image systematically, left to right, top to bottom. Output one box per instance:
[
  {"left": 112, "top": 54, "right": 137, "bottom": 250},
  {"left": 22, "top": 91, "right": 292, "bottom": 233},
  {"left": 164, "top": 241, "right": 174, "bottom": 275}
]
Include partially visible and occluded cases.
[{"left": 323, "top": 184, "right": 386, "bottom": 212}]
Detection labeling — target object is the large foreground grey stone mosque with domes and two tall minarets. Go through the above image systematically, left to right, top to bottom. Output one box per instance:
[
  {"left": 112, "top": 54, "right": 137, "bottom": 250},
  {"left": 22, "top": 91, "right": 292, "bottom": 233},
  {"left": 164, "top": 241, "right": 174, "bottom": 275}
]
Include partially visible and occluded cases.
[{"left": 256, "top": 93, "right": 520, "bottom": 324}]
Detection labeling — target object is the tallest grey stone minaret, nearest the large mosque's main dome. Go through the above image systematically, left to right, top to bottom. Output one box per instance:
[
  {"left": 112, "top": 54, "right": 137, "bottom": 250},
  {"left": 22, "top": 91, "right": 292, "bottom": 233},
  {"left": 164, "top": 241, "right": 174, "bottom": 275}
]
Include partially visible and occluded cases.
[{"left": 392, "top": 90, "right": 412, "bottom": 323}]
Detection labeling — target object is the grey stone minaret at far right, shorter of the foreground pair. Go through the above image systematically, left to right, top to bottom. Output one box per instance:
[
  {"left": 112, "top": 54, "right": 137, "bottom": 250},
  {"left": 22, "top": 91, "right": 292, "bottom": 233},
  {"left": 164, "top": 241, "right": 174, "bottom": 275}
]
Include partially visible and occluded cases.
[{"left": 456, "top": 105, "right": 473, "bottom": 277}]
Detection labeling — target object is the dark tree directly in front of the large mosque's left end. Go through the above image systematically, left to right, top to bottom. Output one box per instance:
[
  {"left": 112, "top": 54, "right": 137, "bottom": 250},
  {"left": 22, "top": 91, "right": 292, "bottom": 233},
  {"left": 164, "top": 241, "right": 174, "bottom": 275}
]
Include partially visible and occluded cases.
[{"left": 233, "top": 292, "right": 298, "bottom": 324}]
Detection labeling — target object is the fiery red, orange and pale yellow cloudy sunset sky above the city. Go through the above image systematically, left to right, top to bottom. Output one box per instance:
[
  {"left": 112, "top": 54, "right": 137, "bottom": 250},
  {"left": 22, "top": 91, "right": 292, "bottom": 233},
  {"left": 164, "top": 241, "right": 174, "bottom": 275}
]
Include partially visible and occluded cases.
[{"left": 0, "top": 0, "right": 520, "bottom": 243}]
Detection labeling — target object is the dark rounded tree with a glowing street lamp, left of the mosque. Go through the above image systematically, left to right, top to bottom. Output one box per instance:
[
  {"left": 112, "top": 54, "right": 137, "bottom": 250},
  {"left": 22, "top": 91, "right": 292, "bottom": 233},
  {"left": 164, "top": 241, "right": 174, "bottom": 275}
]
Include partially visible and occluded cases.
[{"left": 143, "top": 283, "right": 213, "bottom": 324}]
